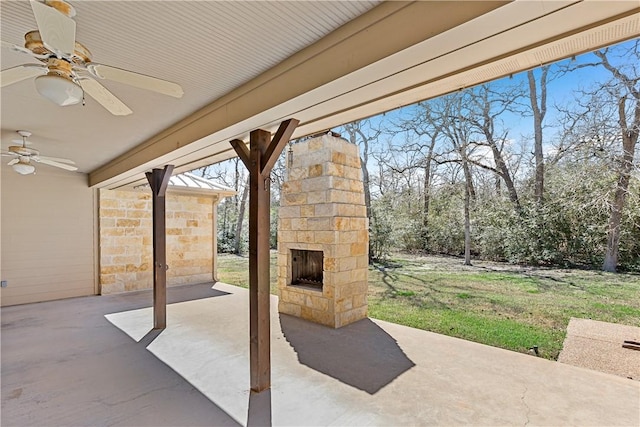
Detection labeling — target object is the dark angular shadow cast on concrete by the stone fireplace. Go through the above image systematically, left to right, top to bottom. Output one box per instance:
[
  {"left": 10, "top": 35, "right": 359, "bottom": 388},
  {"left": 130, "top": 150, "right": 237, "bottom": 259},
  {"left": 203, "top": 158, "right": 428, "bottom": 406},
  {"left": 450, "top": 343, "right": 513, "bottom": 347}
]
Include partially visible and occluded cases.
[{"left": 280, "top": 314, "right": 415, "bottom": 394}]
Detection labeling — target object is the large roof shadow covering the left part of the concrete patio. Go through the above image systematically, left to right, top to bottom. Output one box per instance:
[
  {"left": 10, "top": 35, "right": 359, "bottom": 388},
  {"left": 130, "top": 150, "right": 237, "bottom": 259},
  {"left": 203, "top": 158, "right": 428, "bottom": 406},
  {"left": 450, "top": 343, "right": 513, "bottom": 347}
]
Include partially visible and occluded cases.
[{"left": 0, "top": 283, "right": 239, "bottom": 426}]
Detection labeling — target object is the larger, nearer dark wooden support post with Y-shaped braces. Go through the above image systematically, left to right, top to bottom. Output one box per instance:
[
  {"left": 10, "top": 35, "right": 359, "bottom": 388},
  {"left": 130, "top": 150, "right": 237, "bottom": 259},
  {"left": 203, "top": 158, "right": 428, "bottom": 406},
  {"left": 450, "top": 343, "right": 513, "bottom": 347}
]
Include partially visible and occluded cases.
[{"left": 231, "top": 119, "right": 299, "bottom": 392}]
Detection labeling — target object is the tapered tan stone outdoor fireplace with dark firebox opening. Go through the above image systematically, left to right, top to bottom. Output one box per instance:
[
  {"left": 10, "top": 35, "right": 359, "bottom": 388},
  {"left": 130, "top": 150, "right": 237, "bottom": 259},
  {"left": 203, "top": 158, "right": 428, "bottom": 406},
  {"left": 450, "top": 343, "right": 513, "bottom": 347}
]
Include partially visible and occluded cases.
[{"left": 278, "top": 134, "right": 369, "bottom": 328}]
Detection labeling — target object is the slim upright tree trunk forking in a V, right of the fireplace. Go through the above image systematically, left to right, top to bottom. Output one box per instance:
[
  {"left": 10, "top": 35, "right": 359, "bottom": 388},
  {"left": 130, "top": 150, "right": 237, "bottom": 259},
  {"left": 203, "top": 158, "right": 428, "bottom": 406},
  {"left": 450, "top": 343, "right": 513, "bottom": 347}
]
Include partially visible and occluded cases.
[{"left": 527, "top": 66, "right": 549, "bottom": 204}]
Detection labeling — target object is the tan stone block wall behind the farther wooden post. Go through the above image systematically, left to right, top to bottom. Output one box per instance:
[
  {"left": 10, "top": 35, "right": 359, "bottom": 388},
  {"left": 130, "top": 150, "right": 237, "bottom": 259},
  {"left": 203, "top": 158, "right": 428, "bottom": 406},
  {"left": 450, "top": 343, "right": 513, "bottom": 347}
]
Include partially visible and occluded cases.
[{"left": 99, "top": 190, "right": 215, "bottom": 294}]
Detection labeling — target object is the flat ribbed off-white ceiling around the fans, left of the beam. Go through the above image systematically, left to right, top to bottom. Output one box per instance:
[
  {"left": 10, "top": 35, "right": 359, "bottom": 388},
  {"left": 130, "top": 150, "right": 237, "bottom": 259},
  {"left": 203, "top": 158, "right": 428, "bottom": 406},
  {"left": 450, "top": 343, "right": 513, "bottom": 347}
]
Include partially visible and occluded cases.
[{"left": 0, "top": 0, "right": 380, "bottom": 172}]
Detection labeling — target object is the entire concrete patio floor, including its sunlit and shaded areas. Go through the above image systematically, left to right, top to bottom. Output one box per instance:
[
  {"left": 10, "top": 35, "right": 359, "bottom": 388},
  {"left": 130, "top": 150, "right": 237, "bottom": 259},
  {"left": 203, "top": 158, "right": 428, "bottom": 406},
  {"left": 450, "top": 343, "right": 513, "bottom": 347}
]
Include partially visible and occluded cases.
[{"left": 1, "top": 283, "right": 640, "bottom": 426}]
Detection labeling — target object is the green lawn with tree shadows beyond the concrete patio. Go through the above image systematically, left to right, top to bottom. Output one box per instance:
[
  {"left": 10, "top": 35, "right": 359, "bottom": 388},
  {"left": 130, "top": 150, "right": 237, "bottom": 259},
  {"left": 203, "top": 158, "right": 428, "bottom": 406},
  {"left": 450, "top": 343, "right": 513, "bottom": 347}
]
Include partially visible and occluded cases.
[{"left": 218, "top": 254, "right": 640, "bottom": 359}]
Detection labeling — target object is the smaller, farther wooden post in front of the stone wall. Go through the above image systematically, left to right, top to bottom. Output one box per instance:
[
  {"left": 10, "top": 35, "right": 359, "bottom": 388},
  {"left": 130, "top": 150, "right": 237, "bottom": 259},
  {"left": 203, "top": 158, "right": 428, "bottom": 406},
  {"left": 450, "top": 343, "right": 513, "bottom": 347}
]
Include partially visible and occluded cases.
[{"left": 146, "top": 165, "right": 173, "bottom": 329}]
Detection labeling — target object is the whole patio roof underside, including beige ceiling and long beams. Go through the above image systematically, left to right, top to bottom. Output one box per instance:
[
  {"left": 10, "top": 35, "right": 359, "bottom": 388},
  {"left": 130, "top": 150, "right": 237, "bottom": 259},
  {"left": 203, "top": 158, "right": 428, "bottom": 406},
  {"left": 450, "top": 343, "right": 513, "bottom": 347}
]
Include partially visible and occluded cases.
[{"left": 0, "top": 0, "right": 640, "bottom": 188}]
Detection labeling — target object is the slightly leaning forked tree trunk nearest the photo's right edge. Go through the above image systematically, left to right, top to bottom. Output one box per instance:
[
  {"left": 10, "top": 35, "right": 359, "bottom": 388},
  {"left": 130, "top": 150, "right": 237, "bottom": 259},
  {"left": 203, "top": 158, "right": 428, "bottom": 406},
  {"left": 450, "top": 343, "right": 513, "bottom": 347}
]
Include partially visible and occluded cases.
[{"left": 602, "top": 97, "right": 640, "bottom": 272}]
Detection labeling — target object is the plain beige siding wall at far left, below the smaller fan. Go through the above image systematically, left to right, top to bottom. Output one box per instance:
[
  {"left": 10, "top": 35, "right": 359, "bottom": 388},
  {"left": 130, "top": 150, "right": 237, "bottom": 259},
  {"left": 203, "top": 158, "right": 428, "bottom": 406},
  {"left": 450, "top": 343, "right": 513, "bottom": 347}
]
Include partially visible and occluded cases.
[{"left": 0, "top": 165, "right": 97, "bottom": 305}]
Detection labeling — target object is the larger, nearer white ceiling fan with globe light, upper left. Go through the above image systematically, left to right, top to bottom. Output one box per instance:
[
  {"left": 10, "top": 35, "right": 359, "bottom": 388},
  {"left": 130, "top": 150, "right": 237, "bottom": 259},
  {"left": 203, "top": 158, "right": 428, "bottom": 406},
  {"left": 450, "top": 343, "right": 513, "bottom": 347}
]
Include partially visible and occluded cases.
[{"left": 0, "top": 0, "right": 184, "bottom": 116}]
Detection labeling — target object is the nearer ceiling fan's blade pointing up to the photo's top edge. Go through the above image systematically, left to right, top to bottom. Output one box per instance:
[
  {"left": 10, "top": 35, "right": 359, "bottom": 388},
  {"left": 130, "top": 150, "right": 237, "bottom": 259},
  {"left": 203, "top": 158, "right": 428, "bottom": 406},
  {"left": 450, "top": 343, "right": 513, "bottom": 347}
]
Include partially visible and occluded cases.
[{"left": 31, "top": 0, "right": 76, "bottom": 58}]
